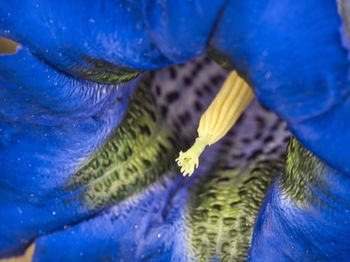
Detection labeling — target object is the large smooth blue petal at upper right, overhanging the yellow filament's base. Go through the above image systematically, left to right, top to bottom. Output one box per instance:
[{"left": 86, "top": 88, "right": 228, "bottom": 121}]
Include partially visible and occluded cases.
[{"left": 210, "top": 0, "right": 350, "bottom": 174}]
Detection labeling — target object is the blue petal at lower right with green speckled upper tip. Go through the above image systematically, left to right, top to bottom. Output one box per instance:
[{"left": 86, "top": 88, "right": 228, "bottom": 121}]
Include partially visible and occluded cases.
[{"left": 249, "top": 138, "right": 350, "bottom": 261}]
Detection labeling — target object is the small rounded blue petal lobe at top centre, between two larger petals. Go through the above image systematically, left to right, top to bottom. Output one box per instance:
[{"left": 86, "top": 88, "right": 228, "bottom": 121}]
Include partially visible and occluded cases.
[{"left": 142, "top": 0, "right": 227, "bottom": 63}]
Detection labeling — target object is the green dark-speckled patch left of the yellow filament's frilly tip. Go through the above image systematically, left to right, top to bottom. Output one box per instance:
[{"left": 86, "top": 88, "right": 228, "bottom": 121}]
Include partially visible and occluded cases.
[{"left": 70, "top": 75, "right": 178, "bottom": 207}]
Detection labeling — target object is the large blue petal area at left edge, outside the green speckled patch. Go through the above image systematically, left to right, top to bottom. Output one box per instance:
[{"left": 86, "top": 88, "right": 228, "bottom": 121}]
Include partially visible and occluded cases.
[{"left": 0, "top": 48, "right": 135, "bottom": 257}]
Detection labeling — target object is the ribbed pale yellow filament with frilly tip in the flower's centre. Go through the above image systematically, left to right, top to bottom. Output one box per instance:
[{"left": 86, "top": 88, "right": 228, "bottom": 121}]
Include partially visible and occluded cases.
[{"left": 176, "top": 71, "right": 254, "bottom": 176}]
